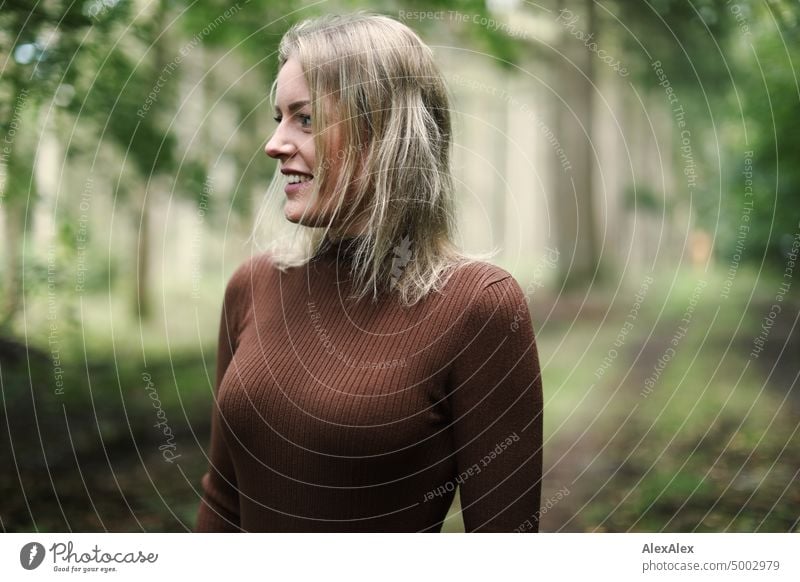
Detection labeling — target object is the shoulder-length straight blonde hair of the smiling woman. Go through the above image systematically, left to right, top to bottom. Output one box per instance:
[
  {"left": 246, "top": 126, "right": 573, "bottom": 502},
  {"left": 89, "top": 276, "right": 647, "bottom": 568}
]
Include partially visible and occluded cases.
[{"left": 256, "top": 13, "right": 493, "bottom": 306}]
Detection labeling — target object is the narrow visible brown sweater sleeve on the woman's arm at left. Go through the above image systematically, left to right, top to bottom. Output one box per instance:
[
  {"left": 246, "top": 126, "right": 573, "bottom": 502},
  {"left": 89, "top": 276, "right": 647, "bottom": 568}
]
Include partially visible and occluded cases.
[{"left": 195, "top": 267, "right": 250, "bottom": 532}]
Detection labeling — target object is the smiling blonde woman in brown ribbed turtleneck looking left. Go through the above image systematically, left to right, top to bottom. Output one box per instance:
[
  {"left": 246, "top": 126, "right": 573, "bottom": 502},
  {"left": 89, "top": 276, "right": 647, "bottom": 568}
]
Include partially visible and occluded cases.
[{"left": 196, "top": 14, "right": 542, "bottom": 532}]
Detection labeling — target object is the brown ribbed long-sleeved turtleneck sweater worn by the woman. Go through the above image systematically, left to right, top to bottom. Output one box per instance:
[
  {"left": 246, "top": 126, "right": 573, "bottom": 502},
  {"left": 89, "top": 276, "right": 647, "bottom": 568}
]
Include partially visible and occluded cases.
[{"left": 196, "top": 238, "right": 542, "bottom": 532}]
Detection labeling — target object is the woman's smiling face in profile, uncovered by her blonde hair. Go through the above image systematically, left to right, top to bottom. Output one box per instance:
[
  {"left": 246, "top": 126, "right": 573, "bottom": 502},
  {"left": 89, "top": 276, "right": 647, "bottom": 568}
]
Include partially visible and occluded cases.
[{"left": 264, "top": 58, "right": 320, "bottom": 226}]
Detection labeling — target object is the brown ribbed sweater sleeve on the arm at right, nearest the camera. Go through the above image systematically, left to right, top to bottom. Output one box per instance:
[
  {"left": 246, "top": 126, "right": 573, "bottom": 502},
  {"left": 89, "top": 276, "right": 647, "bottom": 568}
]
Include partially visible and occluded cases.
[{"left": 448, "top": 275, "right": 543, "bottom": 532}]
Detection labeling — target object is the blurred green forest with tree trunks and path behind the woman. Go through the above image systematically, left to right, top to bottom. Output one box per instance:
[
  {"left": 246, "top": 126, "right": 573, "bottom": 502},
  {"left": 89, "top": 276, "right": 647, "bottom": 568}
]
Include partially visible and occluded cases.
[{"left": 0, "top": 0, "right": 800, "bottom": 532}]
